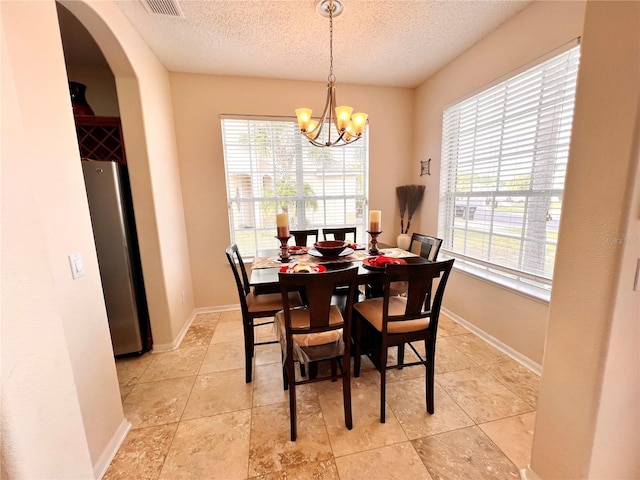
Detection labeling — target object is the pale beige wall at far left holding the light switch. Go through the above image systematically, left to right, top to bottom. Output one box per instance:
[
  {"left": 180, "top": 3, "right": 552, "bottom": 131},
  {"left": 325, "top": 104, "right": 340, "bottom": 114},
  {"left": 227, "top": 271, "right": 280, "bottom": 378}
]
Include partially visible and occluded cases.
[{"left": 0, "top": 1, "right": 126, "bottom": 478}]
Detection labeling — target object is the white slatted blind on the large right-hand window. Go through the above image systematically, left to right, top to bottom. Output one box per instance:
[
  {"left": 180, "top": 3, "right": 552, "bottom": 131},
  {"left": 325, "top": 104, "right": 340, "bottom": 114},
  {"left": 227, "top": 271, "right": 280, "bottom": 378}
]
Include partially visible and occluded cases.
[{"left": 439, "top": 46, "right": 580, "bottom": 290}]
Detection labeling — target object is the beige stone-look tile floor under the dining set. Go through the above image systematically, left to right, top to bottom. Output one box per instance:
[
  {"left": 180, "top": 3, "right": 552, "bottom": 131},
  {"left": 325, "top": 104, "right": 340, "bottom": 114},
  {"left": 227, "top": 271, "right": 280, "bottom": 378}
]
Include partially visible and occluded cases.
[{"left": 104, "top": 311, "right": 538, "bottom": 480}]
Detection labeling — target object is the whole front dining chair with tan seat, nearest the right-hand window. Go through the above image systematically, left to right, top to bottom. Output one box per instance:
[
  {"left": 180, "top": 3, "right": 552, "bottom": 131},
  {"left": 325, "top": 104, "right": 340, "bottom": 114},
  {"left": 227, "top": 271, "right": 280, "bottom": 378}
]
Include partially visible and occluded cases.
[{"left": 353, "top": 259, "right": 454, "bottom": 423}]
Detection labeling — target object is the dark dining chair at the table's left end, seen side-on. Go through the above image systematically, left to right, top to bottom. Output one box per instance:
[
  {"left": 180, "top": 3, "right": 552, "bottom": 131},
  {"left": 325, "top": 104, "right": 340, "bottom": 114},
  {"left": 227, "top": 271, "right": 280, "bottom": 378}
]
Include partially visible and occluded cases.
[{"left": 226, "top": 243, "right": 302, "bottom": 383}]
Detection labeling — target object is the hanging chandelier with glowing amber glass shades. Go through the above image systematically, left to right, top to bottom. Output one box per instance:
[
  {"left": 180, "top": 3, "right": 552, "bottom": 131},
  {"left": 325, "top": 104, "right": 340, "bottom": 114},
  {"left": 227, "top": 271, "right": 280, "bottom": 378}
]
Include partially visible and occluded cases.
[{"left": 296, "top": 0, "right": 367, "bottom": 147}]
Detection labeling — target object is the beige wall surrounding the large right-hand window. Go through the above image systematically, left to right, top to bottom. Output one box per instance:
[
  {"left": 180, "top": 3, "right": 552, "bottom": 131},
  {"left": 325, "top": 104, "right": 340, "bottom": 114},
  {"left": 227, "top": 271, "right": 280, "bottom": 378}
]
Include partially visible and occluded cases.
[{"left": 413, "top": 2, "right": 584, "bottom": 365}]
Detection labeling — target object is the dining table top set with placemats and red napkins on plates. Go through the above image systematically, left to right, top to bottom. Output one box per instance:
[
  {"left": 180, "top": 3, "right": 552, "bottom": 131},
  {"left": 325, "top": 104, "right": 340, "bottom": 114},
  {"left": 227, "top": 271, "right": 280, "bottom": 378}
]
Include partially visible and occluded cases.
[{"left": 249, "top": 245, "right": 427, "bottom": 292}]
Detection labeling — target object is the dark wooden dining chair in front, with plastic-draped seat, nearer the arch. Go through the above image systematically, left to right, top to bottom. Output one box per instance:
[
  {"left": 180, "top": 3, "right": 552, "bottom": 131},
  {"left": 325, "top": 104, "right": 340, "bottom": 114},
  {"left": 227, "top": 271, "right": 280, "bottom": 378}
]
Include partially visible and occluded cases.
[{"left": 275, "top": 267, "right": 358, "bottom": 442}]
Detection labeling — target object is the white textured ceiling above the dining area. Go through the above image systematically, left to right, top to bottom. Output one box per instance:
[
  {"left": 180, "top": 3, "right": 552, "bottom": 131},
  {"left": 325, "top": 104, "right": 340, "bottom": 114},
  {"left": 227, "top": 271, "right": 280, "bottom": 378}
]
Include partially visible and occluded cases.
[{"left": 65, "top": 0, "right": 529, "bottom": 87}]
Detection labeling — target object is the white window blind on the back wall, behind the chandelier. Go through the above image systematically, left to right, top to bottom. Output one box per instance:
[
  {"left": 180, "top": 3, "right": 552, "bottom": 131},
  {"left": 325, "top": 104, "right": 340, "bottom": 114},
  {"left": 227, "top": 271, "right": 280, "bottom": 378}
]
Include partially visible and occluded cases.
[{"left": 221, "top": 116, "right": 369, "bottom": 257}]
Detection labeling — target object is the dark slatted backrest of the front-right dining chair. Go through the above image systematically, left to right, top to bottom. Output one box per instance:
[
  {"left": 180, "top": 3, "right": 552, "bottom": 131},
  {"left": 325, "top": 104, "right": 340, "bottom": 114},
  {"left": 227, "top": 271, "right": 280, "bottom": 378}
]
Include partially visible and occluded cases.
[{"left": 382, "top": 259, "right": 454, "bottom": 333}]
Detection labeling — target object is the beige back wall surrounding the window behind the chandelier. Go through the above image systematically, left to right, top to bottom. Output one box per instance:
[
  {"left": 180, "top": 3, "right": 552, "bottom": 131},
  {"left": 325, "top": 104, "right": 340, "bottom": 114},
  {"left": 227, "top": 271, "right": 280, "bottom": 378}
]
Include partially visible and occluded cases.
[{"left": 170, "top": 73, "right": 410, "bottom": 307}]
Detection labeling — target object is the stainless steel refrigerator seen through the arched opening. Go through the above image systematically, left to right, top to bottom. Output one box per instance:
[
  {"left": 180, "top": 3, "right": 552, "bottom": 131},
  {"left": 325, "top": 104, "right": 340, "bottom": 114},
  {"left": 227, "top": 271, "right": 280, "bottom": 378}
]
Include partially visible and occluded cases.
[{"left": 82, "top": 160, "right": 151, "bottom": 356}]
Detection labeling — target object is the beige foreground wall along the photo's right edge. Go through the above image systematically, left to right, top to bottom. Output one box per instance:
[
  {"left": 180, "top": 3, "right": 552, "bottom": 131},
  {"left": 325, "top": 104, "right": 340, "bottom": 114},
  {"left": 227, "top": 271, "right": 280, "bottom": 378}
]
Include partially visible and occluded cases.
[{"left": 531, "top": 2, "right": 640, "bottom": 479}]
